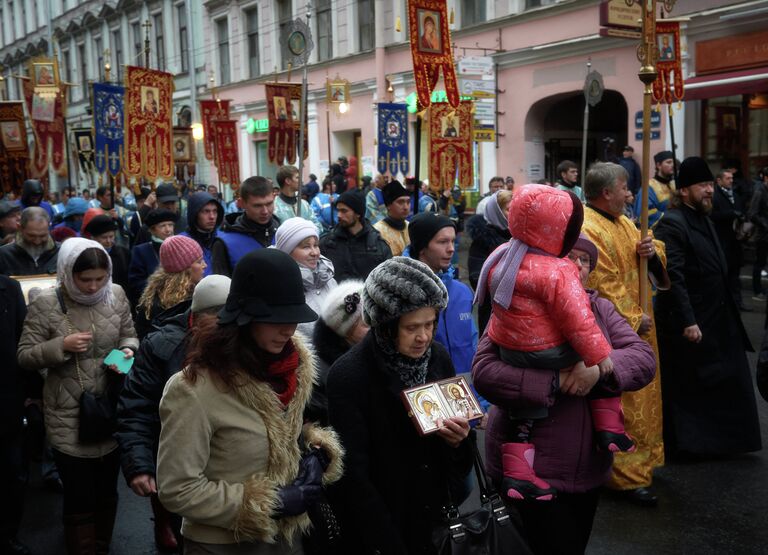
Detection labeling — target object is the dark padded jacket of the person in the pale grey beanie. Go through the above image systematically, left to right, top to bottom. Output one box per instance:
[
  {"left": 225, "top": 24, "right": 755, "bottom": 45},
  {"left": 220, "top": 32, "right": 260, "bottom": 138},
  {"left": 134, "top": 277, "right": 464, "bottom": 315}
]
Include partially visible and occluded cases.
[{"left": 115, "top": 311, "right": 189, "bottom": 483}]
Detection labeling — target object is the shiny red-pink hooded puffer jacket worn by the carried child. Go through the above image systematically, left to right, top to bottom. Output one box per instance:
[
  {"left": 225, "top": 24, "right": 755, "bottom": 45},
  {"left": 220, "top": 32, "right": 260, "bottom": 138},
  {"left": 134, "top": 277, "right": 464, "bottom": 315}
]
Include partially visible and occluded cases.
[{"left": 488, "top": 185, "right": 611, "bottom": 366}]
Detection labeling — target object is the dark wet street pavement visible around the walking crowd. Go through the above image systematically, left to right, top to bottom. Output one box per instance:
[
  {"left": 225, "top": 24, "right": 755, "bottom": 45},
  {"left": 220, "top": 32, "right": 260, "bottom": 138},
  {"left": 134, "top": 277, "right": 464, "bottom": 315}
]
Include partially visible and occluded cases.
[{"left": 21, "top": 262, "right": 768, "bottom": 555}]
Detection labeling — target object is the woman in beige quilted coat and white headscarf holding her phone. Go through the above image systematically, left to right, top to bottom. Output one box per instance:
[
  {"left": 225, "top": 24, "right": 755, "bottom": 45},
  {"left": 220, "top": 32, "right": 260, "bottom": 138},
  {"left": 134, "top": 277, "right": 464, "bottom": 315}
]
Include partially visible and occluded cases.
[{"left": 18, "top": 238, "right": 139, "bottom": 555}]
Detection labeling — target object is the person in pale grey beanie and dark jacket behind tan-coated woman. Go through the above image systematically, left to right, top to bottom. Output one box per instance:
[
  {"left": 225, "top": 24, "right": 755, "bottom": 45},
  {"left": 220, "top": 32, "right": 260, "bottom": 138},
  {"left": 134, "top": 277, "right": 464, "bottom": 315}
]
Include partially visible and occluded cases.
[{"left": 115, "top": 275, "right": 230, "bottom": 550}]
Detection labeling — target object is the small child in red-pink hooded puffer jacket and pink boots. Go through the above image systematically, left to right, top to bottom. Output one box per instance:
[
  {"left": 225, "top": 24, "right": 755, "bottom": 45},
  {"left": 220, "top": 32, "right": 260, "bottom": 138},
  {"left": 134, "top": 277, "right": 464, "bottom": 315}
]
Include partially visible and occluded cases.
[{"left": 475, "top": 185, "right": 635, "bottom": 500}]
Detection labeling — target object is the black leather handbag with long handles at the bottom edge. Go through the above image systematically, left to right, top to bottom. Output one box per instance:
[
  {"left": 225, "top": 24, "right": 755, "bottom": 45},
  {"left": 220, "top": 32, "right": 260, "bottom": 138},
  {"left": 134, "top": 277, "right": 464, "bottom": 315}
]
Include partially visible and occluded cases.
[{"left": 432, "top": 435, "right": 532, "bottom": 555}]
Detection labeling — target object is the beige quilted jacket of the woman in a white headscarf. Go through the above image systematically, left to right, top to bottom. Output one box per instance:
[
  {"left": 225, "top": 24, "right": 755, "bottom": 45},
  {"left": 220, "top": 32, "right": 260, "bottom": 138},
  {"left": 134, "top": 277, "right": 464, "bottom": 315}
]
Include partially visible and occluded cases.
[{"left": 17, "top": 284, "right": 139, "bottom": 458}]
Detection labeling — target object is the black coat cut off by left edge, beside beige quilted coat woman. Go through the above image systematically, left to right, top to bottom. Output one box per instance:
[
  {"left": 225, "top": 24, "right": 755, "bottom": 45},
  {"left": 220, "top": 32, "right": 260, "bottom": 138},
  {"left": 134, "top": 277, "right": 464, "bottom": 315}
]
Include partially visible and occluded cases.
[{"left": 0, "top": 276, "right": 27, "bottom": 436}]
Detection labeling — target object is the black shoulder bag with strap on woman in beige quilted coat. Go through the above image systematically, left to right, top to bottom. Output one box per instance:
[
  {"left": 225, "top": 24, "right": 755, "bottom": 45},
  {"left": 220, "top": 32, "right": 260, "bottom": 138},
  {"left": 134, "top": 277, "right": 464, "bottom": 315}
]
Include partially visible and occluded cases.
[{"left": 56, "top": 288, "right": 123, "bottom": 443}]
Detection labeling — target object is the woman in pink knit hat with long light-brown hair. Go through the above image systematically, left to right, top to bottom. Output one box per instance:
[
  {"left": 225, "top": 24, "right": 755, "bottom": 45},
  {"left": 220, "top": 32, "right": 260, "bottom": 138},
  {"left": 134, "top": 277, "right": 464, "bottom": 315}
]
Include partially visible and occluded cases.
[{"left": 136, "top": 235, "right": 206, "bottom": 339}]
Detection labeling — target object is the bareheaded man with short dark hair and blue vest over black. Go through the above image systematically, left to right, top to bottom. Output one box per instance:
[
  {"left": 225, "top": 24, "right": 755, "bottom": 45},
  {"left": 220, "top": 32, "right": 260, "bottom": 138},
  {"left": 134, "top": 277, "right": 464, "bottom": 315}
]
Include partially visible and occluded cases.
[{"left": 211, "top": 175, "right": 280, "bottom": 276}]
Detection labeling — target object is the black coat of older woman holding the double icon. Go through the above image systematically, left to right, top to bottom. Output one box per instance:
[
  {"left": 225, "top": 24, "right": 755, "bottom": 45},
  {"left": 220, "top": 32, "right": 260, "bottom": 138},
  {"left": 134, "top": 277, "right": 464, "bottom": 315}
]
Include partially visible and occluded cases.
[{"left": 328, "top": 332, "right": 473, "bottom": 555}]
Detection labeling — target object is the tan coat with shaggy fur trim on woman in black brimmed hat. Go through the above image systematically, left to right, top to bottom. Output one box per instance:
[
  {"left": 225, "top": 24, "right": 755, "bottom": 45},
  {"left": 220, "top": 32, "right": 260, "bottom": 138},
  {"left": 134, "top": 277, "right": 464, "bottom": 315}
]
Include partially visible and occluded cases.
[{"left": 157, "top": 336, "right": 342, "bottom": 544}]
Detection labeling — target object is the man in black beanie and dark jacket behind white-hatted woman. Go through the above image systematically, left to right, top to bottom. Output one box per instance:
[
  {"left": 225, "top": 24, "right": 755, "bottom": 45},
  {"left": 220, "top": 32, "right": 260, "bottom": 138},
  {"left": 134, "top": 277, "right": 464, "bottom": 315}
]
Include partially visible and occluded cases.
[{"left": 320, "top": 191, "right": 392, "bottom": 281}]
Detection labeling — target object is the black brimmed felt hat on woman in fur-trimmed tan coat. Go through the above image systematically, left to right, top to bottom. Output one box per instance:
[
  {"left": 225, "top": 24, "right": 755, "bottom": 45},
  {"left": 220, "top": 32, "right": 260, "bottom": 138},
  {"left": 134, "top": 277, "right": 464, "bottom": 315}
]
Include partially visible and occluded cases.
[{"left": 219, "top": 249, "right": 317, "bottom": 326}]
